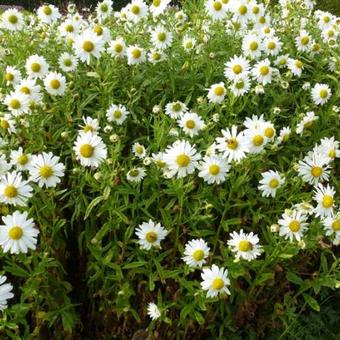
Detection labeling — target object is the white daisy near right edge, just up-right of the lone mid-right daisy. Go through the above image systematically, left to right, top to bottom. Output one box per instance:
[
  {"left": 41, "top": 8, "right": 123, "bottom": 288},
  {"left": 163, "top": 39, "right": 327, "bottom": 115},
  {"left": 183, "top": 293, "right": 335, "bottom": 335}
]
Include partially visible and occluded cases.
[{"left": 298, "top": 152, "right": 330, "bottom": 185}]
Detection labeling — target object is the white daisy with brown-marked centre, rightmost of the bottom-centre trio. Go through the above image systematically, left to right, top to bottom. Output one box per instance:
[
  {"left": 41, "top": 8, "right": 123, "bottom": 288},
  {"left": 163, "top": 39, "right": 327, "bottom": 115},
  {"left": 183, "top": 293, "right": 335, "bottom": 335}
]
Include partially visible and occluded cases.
[{"left": 228, "top": 229, "right": 262, "bottom": 261}]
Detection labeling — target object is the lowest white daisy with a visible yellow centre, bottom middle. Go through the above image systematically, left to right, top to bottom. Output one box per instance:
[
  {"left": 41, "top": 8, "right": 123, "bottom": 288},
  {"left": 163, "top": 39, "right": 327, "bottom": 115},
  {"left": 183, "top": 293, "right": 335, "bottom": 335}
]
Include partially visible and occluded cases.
[{"left": 201, "top": 264, "right": 230, "bottom": 298}]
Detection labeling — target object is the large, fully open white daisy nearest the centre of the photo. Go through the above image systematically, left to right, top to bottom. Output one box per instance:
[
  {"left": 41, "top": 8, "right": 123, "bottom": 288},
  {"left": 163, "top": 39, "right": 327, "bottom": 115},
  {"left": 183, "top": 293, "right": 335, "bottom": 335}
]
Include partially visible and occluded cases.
[{"left": 163, "top": 140, "right": 201, "bottom": 178}]
